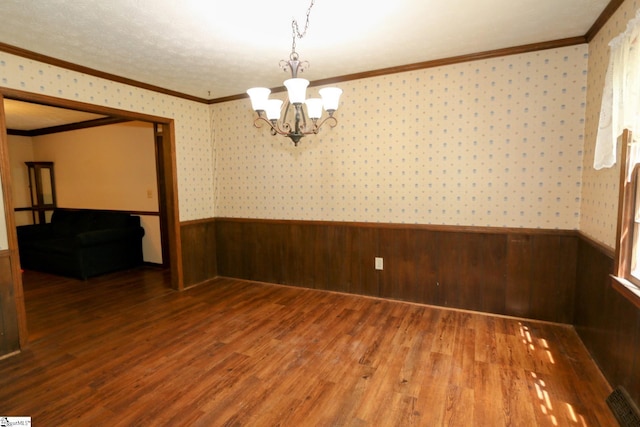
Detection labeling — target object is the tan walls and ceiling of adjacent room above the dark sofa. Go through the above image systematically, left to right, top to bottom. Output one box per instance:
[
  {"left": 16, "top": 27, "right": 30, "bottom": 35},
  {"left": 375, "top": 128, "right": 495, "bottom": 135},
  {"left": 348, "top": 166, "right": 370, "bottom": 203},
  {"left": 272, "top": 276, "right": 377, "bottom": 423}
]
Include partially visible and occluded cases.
[{"left": 4, "top": 111, "right": 163, "bottom": 265}]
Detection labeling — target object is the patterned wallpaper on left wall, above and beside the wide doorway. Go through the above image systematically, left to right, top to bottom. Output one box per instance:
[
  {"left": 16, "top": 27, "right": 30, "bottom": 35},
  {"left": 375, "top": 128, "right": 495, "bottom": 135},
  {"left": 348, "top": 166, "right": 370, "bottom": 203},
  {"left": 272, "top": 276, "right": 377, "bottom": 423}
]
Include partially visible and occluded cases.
[{"left": 0, "top": 52, "right": 214, "bottom": 221}]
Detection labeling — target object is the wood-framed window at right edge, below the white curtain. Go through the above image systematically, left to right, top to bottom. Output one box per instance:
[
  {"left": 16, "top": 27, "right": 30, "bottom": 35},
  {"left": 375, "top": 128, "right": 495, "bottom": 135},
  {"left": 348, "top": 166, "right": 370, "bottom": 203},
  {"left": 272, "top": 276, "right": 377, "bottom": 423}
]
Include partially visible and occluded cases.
[{"left": 613, "top": 129, "right": 640, "bottom": 307}]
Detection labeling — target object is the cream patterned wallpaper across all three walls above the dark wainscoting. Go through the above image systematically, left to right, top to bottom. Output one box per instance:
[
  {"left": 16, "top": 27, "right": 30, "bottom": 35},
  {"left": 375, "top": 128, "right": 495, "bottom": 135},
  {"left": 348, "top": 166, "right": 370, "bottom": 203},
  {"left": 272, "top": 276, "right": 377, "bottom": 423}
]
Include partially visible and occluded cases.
[{"left": 0, "top": 0, "right": 640, "bottom": 236}]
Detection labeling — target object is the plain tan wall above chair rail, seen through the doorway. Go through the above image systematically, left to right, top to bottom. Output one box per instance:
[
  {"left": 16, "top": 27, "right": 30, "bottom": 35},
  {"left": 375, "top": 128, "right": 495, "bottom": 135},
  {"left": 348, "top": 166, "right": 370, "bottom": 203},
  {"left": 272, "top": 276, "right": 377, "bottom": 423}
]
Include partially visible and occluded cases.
[{"left": 33, "top": 122, "right": 158, "bottom": 212}]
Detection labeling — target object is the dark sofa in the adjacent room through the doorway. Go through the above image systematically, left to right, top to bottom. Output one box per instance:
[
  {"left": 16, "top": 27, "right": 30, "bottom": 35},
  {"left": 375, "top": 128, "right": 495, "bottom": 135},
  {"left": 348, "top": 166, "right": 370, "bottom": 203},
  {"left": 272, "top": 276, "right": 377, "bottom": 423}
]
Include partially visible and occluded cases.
[{"left": 17, "top": 209, "right": 144, "bottom": 279}]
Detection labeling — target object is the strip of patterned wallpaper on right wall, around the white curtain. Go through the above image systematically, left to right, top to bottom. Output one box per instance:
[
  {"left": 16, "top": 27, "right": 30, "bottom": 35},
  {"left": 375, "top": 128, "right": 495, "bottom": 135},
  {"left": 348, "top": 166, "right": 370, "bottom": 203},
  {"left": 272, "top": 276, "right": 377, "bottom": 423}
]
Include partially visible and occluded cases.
[{"left": 580, "top": 0, "right": 640, "bottom": 248}]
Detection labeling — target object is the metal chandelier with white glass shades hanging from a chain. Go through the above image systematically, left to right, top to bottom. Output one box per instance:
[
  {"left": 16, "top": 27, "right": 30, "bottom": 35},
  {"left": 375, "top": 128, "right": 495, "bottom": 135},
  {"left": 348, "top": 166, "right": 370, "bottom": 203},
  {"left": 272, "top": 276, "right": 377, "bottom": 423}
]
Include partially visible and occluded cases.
[{"left": 247, "top": 0, "right": 342, "bottom": 147}]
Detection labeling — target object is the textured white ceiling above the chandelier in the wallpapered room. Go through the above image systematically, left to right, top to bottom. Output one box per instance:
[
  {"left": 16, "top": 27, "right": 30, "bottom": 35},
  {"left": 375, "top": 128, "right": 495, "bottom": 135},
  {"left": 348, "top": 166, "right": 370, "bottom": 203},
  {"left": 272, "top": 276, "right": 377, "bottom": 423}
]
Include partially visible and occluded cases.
[{"left": 0, "top": 0, "right": 609, "bottom": 99}]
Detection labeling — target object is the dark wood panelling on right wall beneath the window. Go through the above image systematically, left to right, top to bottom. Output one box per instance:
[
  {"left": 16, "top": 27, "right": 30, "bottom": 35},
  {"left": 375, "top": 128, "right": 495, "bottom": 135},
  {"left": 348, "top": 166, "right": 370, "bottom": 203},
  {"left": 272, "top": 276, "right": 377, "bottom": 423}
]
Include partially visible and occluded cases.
[{"left": 574, "top": 237, "right": 640, "bottom": 405}]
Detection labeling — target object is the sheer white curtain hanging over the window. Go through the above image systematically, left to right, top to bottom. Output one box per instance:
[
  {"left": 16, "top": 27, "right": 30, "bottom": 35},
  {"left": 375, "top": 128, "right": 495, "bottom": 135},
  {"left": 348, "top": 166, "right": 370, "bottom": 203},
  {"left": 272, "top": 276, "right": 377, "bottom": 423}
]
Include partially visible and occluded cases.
[{"left": 593, "top": 10, "right": 640, "bottom": 169}]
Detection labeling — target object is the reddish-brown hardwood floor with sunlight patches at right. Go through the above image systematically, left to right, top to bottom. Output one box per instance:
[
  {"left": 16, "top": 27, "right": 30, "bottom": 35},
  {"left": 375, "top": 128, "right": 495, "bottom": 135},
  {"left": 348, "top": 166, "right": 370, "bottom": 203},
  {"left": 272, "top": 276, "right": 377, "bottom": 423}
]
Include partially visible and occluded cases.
[{"left": 0, "top": 269, "right": 617, "bottom": 426}]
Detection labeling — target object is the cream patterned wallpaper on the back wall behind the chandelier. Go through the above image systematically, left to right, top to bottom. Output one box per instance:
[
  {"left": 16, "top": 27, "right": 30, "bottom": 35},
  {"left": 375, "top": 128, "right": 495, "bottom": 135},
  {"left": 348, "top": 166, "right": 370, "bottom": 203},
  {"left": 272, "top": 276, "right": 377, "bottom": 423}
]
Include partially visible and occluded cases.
[{"left": 212, "top": 45, "right": 588, "bottom": 229}]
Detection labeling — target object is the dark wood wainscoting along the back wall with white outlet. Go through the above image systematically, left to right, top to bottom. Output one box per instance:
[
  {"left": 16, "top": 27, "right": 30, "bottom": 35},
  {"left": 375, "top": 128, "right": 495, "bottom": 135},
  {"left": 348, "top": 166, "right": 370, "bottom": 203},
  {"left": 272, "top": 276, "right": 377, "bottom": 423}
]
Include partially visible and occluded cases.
[{"left": 209, "top": 218, "right": 578, "bottom": 323}]
